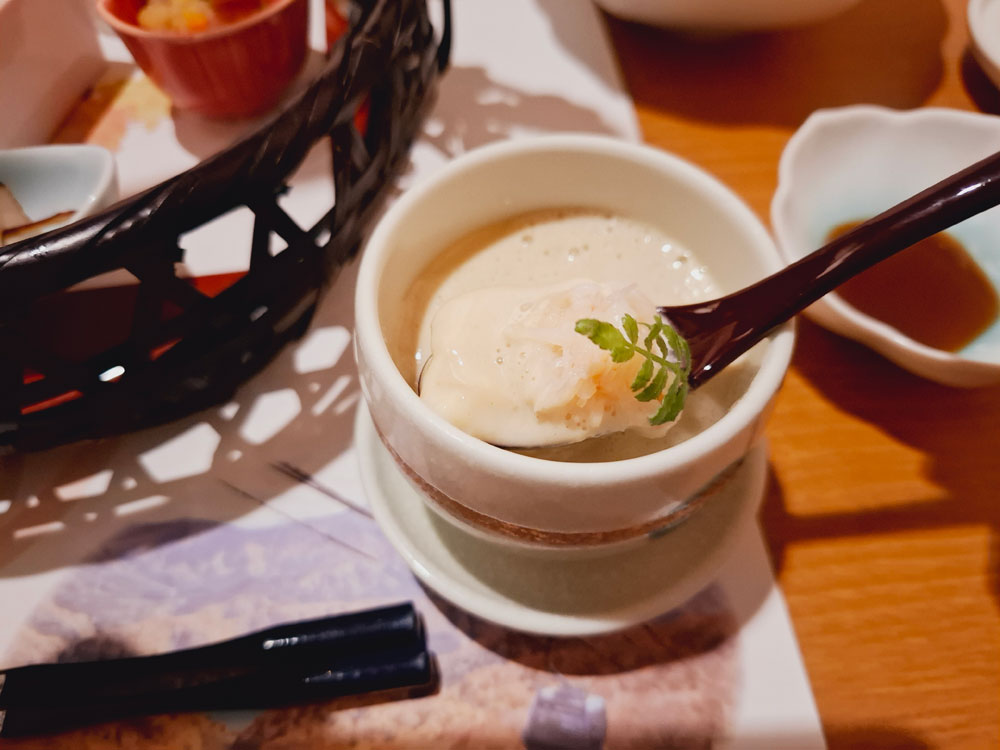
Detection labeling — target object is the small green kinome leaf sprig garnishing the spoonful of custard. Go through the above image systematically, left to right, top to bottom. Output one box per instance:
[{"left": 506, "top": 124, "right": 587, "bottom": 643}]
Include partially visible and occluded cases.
[{"left": 576, "top": 314, "right": 691, "bottom": 425}]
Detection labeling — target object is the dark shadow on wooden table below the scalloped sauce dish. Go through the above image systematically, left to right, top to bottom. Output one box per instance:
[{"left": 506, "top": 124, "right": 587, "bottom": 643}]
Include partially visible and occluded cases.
[{"left": 762, "top": 320, "right": 1000, "bottom": 595}]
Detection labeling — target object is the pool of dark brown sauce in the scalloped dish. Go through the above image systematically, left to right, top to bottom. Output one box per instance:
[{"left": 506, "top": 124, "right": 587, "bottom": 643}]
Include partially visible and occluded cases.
[{"left": 827, "top": 222, "right": 1000, "bottom": 352}]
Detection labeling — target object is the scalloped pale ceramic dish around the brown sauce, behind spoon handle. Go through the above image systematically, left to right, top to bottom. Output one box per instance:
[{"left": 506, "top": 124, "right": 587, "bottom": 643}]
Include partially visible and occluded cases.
[{"left": 771, "top": 106, "right": 1000, "bottom": 387}]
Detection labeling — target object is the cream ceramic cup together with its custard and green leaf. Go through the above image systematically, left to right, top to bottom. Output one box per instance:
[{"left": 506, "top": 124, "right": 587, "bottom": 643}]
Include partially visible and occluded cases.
[{"left": 355, "top": 135, "right": 793, "bottom": 548}]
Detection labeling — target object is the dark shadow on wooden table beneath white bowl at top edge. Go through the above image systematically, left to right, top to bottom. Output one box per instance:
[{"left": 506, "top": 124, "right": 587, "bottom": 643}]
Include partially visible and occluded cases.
[{"left": 607, "top": 0, "right": 947, "bottom": 128}]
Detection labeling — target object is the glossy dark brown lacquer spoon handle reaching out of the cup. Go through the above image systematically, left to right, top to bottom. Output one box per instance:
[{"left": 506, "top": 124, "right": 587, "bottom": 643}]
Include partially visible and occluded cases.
[{"left": 657, "top": 152, "right": 1000, "bottom": 388}]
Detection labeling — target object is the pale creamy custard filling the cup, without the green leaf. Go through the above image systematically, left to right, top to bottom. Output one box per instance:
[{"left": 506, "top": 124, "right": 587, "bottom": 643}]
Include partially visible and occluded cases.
[{"left": 394, "top": 208, "right": 755, "bottom": 461}]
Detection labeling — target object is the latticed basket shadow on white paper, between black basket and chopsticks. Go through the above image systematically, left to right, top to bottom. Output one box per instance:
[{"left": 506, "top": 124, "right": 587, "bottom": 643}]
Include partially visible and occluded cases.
[{"left": 0, "top": 258, "right": 359, "bottom": 577}]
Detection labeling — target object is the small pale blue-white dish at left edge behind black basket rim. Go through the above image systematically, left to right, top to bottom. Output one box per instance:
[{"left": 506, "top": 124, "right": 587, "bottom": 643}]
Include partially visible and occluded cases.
[{"left": 0, "top": 144, "right": 118, "bottom": 244}]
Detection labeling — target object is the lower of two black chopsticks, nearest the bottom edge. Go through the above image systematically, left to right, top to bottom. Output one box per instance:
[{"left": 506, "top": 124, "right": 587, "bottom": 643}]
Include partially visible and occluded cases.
[{"left": 0, "top": 650, "right": 438, "bottom": 737}]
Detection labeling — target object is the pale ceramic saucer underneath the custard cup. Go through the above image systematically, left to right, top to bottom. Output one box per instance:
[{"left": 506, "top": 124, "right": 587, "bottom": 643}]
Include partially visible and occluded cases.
[{"left": 355, "top": 404, "right": 767, "bottom": 636}]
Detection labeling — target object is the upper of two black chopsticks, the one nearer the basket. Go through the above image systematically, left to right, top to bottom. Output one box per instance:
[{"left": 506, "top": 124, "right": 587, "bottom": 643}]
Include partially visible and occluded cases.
[{"left": 0, "top": 603, "right": 425, "bottom": 709}]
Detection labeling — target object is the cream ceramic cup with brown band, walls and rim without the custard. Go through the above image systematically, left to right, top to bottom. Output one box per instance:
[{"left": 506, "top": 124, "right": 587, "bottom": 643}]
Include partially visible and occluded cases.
[{"left": 355, "top": 135, "right": 793, "bottom": 549}]
